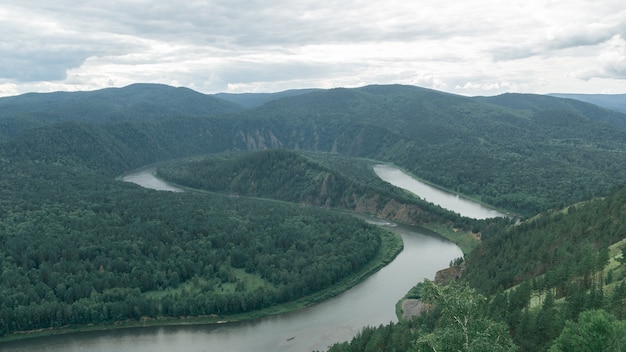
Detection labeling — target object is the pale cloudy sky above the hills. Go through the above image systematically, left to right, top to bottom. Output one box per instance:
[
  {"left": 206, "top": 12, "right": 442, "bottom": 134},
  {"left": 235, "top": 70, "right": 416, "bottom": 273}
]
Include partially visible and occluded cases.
[{"left": 0, "top": 0, "right": 626, "bottom": 96}]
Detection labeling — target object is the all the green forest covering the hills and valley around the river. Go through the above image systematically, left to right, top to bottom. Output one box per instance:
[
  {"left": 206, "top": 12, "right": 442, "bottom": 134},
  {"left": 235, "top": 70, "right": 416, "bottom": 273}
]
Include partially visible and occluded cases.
[{"left": 0, "top": 84, "right": 626, "bottom": 351}]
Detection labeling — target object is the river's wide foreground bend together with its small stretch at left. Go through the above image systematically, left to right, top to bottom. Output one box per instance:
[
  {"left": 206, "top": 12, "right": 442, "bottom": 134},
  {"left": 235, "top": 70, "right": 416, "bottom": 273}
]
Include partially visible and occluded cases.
[{"left": 0, "top": 169, "right": 470, "bottom": 352}]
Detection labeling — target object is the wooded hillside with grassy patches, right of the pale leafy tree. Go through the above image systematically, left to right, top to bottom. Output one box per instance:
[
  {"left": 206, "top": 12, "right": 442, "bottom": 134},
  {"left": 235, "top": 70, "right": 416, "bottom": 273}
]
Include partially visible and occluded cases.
[{"left": 458, "top": 189, "right": 626, "bottom": 351}]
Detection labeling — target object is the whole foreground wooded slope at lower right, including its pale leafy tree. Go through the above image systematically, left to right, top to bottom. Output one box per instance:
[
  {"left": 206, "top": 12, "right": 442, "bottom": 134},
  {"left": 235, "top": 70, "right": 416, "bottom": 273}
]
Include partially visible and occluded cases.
[{"left": 322, "top": 190, "right": 626, "bottom": 351}]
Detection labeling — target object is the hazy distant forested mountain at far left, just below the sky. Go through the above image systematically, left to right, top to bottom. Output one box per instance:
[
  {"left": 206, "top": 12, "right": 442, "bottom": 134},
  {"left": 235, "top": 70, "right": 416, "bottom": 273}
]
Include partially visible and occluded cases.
[{"left": 0, "top": 84, "right": 242, "bottom": 140}]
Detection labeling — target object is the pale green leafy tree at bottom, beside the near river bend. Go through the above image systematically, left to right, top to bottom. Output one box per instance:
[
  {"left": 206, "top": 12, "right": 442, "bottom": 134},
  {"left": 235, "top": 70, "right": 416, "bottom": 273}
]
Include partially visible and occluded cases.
[{"left": 418, "top": 280, "right": 518, "bottom": 352}]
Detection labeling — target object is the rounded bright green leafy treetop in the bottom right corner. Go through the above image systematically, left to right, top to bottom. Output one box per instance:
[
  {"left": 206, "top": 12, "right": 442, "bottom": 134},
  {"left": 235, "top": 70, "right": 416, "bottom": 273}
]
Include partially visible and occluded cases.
[{"left": 549, "top": 310, "right": 626, "bottom": 352}]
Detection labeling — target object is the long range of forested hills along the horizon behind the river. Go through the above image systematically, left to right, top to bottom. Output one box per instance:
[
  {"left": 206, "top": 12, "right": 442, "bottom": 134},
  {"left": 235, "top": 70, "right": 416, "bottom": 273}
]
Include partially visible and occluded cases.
[{"left": 0, "top": 85, "right": 626, "bottom": 216}]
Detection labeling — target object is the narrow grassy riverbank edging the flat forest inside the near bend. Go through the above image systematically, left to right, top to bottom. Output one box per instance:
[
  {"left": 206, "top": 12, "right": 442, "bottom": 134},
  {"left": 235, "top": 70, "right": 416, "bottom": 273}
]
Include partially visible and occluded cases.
[{"left": 0, "top": 231, "right": 404, "bottom": 349}]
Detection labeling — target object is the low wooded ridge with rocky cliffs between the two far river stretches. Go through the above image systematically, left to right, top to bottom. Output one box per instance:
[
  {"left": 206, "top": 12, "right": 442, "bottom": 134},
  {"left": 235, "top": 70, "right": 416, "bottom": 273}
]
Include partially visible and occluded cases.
[{"left": 157, "top": 149, "right": 476, "bottom": 230}]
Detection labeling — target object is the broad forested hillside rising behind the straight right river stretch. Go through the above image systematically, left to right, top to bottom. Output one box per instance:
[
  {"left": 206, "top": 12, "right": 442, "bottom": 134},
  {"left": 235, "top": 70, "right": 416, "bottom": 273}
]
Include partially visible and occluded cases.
[{"left": 235, "top": 86, "right": 626, "bottom": 215}]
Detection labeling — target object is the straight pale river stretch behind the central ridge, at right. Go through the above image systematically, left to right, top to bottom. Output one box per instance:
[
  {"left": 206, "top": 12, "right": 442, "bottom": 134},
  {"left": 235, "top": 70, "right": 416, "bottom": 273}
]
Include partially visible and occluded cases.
[{"left": 374, "top": 165, "right": 507, "bottom": 219}]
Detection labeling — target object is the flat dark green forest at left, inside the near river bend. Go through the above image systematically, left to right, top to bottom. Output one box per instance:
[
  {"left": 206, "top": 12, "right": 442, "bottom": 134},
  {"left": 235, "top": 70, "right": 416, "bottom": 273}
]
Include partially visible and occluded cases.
[{"left": 0, "top": 159, "right": 381, "bottom": 335}]
